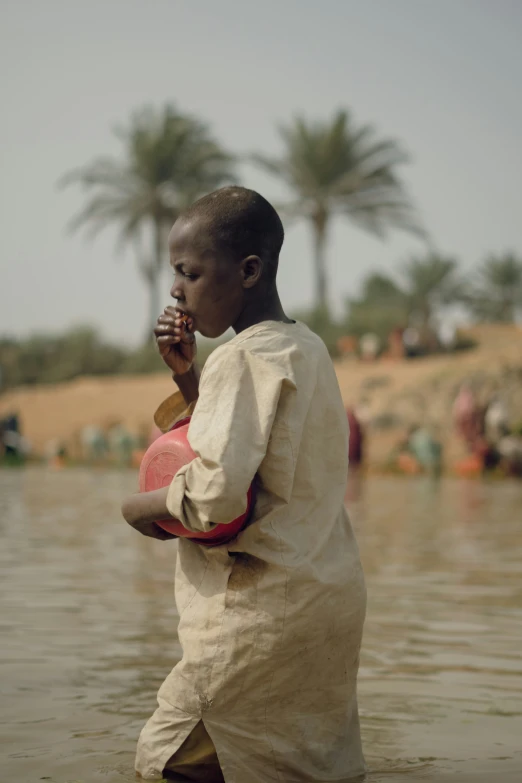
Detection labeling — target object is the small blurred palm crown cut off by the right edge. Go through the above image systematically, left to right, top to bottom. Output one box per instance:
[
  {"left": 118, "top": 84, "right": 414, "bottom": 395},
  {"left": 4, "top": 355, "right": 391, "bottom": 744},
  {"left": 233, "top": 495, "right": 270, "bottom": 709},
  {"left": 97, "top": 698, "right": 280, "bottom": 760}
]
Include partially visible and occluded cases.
[{"left": 468, "top": 253, "right": 522, "bottom": 323}]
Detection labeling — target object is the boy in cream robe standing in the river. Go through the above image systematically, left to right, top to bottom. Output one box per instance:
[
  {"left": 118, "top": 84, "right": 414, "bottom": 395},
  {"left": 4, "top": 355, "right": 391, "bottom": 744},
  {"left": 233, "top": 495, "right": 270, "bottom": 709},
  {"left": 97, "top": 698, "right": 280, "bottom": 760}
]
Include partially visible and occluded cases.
[{"left": 122, "top": 187, "right": 366, "bottom": 783}]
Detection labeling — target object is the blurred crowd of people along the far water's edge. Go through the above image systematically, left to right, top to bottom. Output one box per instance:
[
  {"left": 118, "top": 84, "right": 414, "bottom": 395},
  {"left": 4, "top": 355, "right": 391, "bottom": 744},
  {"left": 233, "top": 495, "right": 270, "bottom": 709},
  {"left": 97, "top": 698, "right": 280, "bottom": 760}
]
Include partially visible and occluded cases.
[{"left": 0, "top": 384, "right": 522, "bottom": 477}]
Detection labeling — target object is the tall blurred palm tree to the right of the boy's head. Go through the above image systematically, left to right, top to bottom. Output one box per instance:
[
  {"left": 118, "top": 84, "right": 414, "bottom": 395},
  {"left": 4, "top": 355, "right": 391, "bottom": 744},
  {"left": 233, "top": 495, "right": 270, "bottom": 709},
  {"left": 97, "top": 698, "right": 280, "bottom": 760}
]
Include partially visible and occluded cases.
[{"left": 254, "top": 111, "right": 424, "bottom": 312}]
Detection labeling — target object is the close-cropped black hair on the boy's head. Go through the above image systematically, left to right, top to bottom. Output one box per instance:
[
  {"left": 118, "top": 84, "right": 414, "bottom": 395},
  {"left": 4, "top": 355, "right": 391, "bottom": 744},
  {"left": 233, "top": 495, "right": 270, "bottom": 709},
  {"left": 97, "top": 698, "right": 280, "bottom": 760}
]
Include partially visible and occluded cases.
[{"left": 180, "top": 185, "right": 285, "bottom": 279}]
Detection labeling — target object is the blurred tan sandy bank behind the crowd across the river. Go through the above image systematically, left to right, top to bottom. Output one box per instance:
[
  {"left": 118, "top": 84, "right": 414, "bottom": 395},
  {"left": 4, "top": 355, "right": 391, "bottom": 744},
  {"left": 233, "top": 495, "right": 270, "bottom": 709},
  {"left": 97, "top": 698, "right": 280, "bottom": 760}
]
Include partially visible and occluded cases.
[{"left": 0, "top": 325, "right": 522, "bottom": 463}]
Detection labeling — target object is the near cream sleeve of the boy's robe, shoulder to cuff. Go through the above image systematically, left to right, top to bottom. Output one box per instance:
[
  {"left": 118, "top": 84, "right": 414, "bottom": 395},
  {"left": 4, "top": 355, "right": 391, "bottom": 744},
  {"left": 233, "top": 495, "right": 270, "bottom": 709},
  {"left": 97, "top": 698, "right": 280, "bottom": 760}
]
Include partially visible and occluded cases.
[{"left": 167, "top": 344, "right": 295, "bottom": 532}]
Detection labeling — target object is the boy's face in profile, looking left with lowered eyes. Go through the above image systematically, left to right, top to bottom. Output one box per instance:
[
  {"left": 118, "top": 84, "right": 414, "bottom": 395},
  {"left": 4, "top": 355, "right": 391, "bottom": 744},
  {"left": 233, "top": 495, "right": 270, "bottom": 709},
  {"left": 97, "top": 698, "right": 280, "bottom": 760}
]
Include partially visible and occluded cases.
[{"left": 169, "top": 219, "right": 245, "bottom": 337}]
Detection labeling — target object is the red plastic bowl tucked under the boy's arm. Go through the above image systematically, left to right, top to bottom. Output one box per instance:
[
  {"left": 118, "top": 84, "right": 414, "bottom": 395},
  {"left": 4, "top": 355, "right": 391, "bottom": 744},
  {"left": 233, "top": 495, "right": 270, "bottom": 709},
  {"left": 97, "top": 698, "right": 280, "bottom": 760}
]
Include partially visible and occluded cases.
[{"left": 140, "top": 417, "right": 252, "bottom": 546}]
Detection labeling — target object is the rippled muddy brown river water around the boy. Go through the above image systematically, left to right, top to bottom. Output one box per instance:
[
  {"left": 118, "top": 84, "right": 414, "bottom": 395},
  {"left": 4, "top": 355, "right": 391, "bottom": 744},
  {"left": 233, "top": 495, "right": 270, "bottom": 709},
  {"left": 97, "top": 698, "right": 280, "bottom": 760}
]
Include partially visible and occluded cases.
[{"left": 0, "top": 468, "right": 522, "bottom": 783}]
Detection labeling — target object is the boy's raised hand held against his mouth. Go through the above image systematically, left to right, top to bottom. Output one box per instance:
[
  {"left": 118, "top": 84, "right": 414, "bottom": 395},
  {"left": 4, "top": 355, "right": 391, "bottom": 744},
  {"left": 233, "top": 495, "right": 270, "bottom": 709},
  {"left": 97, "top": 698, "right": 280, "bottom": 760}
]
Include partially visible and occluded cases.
[{"left": 154, "top": 307, "right": 196, "bottom": 375}]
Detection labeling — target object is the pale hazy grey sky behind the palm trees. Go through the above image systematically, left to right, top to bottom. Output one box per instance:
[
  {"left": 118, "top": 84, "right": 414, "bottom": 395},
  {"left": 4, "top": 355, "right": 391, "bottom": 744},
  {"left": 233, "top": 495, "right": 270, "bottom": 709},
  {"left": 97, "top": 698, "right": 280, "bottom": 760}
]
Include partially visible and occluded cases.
[{"left": 0, "top": 0, "right": 522, "bottom": 342}]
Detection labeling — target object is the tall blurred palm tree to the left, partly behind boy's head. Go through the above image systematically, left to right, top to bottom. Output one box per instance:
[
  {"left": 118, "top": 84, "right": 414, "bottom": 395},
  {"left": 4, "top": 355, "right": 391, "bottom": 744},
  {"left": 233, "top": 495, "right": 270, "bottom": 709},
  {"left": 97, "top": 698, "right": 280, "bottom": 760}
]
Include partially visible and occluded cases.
[{"left": 60, "top": 105, "right": 232, "bottom": 339}]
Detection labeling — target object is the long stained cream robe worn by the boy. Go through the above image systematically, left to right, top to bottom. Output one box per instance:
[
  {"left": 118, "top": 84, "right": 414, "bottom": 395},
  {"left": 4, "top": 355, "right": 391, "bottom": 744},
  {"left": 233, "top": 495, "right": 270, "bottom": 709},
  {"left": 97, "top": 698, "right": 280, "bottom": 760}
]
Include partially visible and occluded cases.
[{"left": 136, "top": 321, "right": 366, "bottom": 783}]
